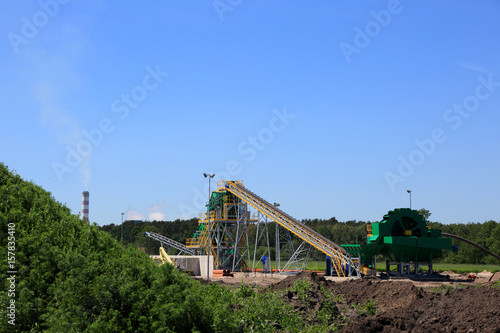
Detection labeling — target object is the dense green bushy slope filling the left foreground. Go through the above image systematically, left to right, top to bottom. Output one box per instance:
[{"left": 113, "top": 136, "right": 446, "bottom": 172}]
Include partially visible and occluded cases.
[{"left": 0, "top": 164, "right": 236, "bottom": 332}]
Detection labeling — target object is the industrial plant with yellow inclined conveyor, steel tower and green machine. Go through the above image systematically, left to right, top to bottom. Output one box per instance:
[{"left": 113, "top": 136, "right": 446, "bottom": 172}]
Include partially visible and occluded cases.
[{"left": 131, "top": 180, "right": 500, "bottom": 281}]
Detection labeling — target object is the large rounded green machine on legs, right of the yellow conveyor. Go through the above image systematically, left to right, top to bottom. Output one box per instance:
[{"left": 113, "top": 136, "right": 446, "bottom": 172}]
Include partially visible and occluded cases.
[{"left": 341, "top": 208, "right": 453, "bottom": 275}]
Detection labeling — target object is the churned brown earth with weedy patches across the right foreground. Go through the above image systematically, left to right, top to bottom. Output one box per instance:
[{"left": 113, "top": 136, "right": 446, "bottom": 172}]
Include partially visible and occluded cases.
[{"left": 215, "top": 272, "right": 500, "bottom": 333}]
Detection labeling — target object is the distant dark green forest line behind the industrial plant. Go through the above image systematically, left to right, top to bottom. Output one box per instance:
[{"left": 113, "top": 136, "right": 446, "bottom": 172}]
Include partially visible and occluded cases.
[{"left": 101, "top": 213, "right": 500, "bottom": 264}]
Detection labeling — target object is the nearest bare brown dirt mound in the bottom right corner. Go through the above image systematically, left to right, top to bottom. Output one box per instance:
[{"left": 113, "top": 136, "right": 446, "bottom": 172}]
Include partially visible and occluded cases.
[{"left": 341, "top": 287, "right": 500, "bottom": 332}]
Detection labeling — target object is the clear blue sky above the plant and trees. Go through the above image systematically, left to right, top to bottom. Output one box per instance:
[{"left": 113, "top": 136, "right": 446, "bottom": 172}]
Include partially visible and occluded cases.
[{"left": 0, "top": 0, "right": 500, "bottom": 225}]
